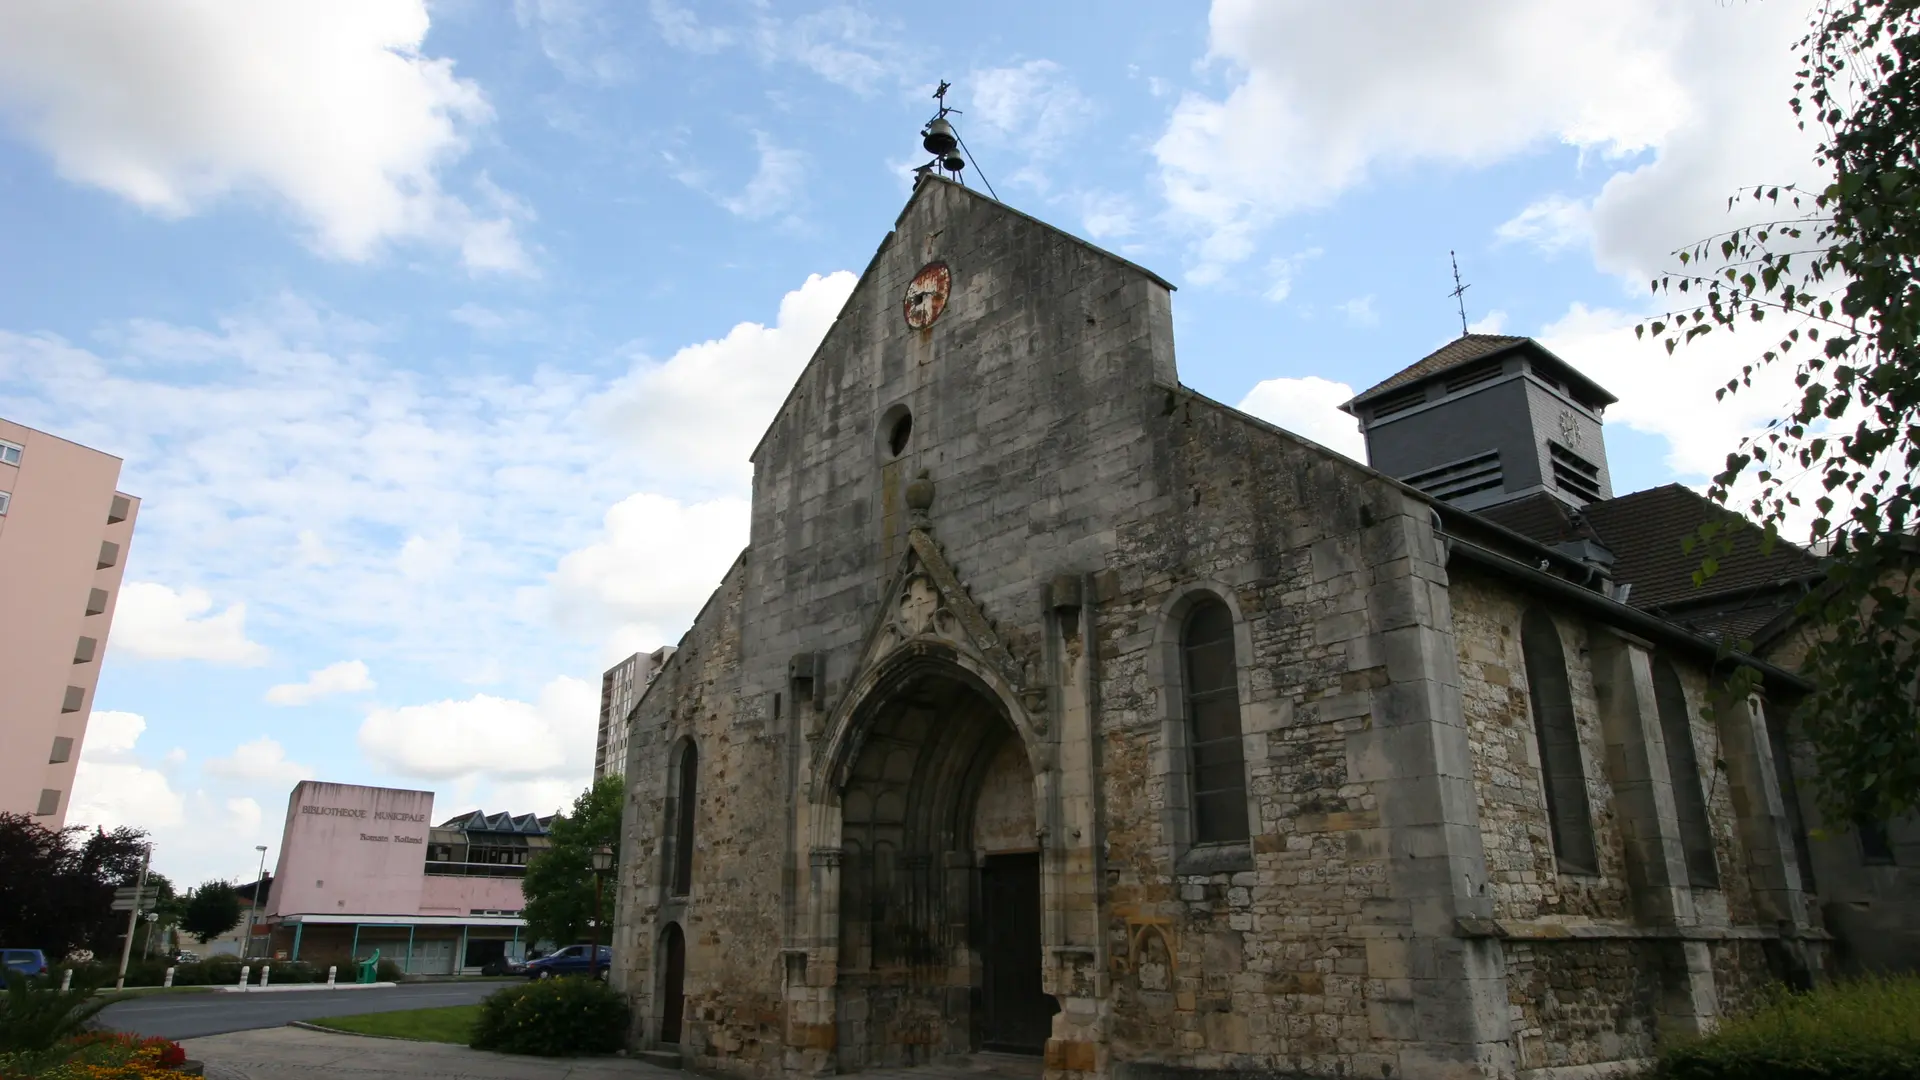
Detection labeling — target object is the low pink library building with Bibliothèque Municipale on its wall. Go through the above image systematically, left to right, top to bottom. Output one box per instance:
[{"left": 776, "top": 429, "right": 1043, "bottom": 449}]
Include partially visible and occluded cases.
[{"left": 253, "top": 780, "right": 553, "bottom": 974}]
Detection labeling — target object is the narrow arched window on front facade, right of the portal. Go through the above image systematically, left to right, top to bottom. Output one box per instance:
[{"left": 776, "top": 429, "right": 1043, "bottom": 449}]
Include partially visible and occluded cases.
[{"left": 1181, "top": 598, "right": 1248, "bottom": 844}]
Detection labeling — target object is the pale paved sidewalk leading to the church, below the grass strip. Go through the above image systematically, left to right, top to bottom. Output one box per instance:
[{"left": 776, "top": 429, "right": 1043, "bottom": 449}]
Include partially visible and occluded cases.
[{"left": 180, "top": 1028, "right": 687, "bottom": 1080}]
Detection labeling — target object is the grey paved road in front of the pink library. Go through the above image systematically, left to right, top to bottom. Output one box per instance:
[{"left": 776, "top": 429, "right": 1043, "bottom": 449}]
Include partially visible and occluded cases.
[{"left": 100, "top": 982, "right": 511, "bottom": 1040}]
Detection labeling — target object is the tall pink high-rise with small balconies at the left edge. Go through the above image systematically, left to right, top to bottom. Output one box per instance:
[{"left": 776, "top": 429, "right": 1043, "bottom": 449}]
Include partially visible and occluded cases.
[{"left": 0, "top": 419, "right": 140, "bottom": 828}]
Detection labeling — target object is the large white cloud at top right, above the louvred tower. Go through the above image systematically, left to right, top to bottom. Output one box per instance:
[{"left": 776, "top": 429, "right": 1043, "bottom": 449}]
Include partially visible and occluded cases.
[{"left": 1154, "top": 0, "right": 1809, "bottom": 281}]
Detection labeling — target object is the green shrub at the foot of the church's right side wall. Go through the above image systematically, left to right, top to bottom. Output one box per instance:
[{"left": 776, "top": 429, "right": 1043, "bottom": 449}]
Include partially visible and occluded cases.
[{"left": 1661, "top": 976, "right": 1920, "bottom": 1080}]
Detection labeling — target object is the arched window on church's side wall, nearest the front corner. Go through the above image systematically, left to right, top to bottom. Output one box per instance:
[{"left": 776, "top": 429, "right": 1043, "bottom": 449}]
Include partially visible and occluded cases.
[{"left": 1521, "top": 607, "right": 1599, "bottom": 874}]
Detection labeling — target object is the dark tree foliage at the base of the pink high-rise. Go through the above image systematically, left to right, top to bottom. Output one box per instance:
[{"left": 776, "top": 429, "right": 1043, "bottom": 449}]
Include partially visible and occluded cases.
[{"left": 0, "top": 813, "right": 146, "bottom": 959}]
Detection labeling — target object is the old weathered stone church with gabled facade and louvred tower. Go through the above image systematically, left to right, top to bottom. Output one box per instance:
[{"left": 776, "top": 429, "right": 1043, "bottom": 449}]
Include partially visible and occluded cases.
[{"left": 614, "top": 175, "right": 1830, "bottom": 1080}]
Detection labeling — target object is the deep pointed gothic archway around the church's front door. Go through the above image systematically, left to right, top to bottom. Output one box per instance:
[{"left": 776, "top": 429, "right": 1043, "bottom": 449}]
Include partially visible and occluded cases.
[{"left": 837, "top": 665, "right": 1054, "bottom": 1070}]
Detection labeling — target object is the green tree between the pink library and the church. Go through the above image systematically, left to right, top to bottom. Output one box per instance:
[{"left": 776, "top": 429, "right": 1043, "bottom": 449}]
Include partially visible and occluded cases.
[{"left": 522, "top": 776, "right": 626, "bottom": 945}]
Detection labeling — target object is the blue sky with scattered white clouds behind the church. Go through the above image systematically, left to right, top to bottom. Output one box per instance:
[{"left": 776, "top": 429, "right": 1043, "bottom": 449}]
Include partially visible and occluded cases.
[{"left": 0, "top": 0, "right": 1820, "bottom": 884}]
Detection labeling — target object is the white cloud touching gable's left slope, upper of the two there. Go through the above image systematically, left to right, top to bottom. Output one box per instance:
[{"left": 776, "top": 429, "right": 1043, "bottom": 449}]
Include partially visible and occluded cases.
[{"left": 605, "top": 271, "right": 856, "bottom": 480}]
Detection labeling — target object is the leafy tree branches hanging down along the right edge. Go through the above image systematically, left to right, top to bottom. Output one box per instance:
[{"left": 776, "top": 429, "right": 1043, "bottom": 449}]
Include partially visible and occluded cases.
[{"left": 1636, "top": 0, "right": 1920, "bottom": 821}]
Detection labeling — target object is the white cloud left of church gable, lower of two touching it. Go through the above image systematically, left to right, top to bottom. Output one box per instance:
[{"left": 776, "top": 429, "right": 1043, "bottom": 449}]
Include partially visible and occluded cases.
[{"left": 547, "top": 494, "right": 753, "bottom": 659}]
